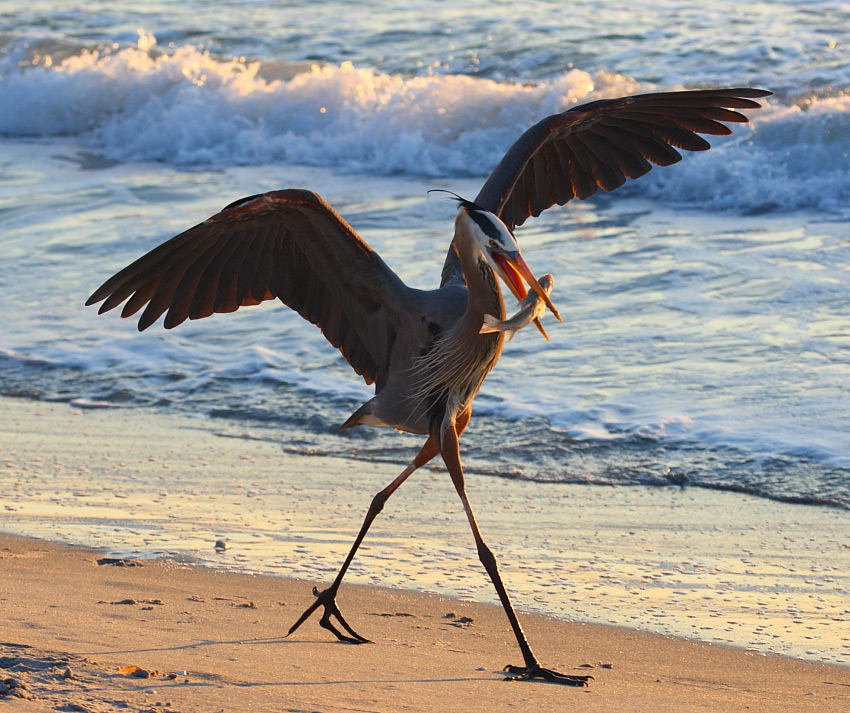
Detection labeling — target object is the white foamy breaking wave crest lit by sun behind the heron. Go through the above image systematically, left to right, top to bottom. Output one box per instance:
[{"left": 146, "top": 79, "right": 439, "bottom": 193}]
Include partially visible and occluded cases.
[{"left": 0, "top": 31, "right": 850, "bottom": 214}]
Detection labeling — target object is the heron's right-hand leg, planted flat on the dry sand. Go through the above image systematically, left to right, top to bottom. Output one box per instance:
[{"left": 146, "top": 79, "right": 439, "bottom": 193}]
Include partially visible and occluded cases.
[{"left": 440, "top": 424, "right": 593, "bottom": 686}]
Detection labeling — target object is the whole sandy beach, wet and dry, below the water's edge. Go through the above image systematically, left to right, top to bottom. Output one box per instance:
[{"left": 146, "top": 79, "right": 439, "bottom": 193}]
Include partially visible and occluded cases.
[{"left": 0, "top": 399, "right": 850, "bottom": 711}]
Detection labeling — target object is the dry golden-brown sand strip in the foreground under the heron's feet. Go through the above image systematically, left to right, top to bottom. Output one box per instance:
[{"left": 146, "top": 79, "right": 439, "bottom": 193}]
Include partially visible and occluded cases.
[{"left": 0, "top": 535, "right": 850, "bottom": 712}]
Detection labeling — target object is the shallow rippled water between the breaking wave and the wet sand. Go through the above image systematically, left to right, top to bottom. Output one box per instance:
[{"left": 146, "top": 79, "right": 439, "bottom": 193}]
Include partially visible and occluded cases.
[{"left": 0, "top": 142, "right": 850, "bottom": 505}]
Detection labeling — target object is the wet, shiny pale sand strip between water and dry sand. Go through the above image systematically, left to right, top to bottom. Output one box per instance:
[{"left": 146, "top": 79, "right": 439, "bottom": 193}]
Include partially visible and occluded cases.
[{"left": 0, "top": 398, "right": 850, "bottom": 665}]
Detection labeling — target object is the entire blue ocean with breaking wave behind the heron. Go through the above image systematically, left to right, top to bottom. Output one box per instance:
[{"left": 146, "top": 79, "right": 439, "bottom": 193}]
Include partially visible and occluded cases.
[{"left": 0, "top": 0, "right": 850, "bottom": 508}]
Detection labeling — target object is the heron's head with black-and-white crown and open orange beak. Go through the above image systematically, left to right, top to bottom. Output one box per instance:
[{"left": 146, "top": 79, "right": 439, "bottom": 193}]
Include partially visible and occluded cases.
[{"left": 440, "top": 196, "right": 563, "bottom": 322}]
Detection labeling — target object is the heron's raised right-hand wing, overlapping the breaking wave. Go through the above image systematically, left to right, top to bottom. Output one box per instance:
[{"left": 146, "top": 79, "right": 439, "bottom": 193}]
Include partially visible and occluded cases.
[{"left": 443, "top": 88, "right": 770, "bottom": 283}]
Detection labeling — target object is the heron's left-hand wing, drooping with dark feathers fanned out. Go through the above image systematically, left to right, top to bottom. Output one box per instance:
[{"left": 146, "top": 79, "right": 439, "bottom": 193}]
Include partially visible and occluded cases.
[{"left": 86, "top": 190, "right": 416, "bottom": 385}]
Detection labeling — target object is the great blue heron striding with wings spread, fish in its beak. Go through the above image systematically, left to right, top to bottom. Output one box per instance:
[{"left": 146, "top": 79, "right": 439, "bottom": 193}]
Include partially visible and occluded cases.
[{"left": 86, "top": 88, "right": 770, "bottom": 686}]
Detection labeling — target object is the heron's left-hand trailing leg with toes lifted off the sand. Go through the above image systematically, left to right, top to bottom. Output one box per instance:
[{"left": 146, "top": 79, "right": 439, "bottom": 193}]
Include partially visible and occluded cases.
[{"left": 286, "top": 432, "right": 444, "bottom": 644}]
